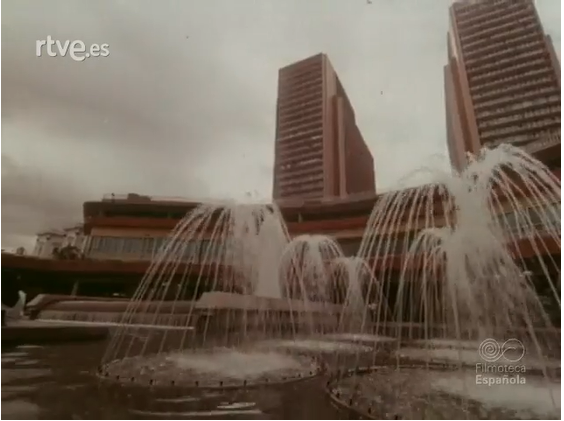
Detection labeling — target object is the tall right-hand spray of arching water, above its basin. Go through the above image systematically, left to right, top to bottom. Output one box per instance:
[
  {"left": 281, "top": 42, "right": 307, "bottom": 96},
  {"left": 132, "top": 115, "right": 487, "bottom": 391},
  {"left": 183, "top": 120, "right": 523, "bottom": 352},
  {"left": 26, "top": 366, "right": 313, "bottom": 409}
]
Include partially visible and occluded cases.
[{"left": 359, "top": 145, "right": 560, "bottom": 339}]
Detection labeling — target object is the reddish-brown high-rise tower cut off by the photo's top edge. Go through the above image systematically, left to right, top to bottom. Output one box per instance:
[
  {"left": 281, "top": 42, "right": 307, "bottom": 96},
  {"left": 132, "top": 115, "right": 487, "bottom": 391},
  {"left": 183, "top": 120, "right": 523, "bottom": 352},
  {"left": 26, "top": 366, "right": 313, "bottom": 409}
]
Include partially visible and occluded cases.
[{"left": 444, "top": 0, "right": 560, "bottom": 169}]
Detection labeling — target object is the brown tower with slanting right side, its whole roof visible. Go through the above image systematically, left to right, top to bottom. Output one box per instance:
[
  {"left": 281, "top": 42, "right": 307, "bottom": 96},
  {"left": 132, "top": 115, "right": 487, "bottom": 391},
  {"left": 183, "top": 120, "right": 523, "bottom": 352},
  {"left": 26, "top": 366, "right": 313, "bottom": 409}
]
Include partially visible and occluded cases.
[{"left": 273, "top": 54, "right": 375, "bottom": 200}]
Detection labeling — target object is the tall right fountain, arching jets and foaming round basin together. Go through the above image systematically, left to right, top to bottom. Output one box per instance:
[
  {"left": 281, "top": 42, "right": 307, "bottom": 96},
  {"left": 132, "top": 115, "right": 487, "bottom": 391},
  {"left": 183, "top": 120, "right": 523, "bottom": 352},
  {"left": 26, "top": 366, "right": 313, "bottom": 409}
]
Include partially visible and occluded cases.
[{"left": 328, "top": 145, "right": 560, "bottom": 419}]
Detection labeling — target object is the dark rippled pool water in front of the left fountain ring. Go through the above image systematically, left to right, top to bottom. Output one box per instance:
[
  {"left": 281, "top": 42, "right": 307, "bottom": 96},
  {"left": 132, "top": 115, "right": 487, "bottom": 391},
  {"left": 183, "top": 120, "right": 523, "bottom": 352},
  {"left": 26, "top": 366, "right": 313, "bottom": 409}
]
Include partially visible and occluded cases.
[{"left": 2, "top": 343, "right": 343, "bottom": 420}]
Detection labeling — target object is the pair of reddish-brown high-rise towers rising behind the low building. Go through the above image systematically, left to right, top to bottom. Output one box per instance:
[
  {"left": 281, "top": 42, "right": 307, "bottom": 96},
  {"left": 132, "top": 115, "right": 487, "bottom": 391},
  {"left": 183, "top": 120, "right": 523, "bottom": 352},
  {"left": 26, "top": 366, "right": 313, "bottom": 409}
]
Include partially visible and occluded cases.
[{"left": 273, "top": 0, "right": 561, "bottom": 202}]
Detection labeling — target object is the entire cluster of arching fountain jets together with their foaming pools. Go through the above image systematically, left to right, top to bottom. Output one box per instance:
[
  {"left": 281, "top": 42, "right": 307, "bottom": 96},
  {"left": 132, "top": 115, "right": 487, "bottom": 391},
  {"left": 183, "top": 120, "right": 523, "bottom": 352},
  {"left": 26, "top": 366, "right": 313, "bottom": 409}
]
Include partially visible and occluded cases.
[{"left": 100, "top": 145, "right": 561, "bottom": 419}]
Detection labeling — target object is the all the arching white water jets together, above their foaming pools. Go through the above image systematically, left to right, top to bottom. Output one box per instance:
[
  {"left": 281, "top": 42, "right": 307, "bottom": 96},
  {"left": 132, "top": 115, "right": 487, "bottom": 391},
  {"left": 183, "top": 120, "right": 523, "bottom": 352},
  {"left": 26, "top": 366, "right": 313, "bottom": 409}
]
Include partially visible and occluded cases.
[{"left": 98, "top": 145, "right": 561, "bottom": 412}]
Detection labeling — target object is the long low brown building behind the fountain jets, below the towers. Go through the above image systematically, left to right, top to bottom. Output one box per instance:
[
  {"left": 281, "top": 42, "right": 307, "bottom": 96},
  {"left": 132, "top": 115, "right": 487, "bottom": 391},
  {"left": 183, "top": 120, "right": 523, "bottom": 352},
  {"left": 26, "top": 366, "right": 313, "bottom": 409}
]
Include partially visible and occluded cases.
[{"left": 2, "top": 170, "right": 560, "bottom": 306}]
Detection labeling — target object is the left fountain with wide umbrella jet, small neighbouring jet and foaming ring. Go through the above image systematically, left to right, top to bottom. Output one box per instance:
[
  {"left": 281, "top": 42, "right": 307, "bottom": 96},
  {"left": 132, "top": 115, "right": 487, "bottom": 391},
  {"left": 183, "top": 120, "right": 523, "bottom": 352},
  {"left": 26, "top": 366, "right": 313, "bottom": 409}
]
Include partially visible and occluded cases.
[{"left": 100, "top": 204, "right": 369, "bottom": 388}]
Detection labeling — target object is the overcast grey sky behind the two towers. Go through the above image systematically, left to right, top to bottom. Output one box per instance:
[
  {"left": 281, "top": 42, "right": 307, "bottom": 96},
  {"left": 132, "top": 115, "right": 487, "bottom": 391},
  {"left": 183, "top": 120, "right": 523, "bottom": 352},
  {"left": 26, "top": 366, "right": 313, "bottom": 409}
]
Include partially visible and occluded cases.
[{"left": 2, "top": 0, "right": 560, "bottom": 248}]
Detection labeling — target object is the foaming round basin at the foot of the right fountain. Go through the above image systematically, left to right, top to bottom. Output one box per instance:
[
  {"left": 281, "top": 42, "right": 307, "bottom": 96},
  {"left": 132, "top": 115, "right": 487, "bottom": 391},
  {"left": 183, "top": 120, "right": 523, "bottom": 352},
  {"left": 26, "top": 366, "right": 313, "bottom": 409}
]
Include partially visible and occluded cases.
[{"left": 326, "top": 364, "right": 560, "bottom": 419}]
